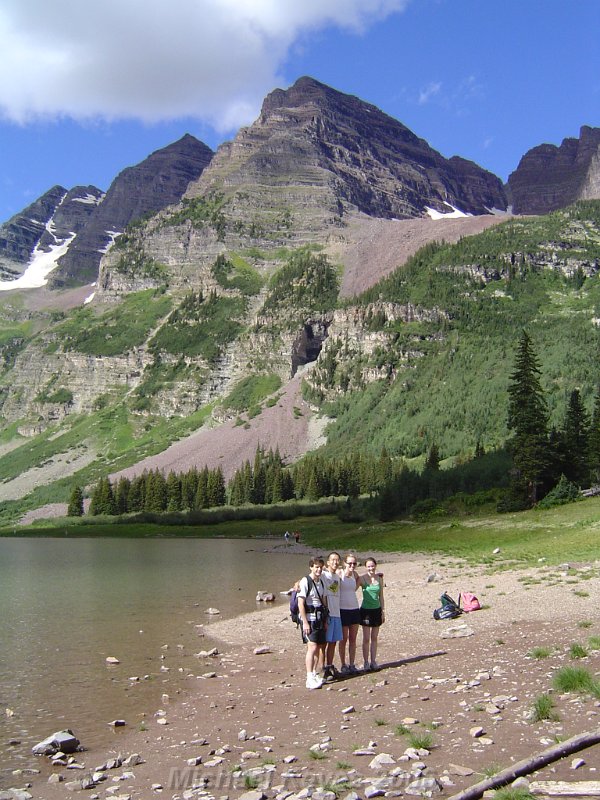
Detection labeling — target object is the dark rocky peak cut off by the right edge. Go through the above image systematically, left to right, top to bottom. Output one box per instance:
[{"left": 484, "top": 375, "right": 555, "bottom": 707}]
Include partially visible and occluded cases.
[{"left": 508, "top": 125, "right": 600, "bottom": 214}]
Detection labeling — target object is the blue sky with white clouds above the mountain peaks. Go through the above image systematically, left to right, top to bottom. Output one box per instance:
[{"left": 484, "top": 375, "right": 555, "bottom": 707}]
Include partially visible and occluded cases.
[{"left": 0, "top": 0, "right": 600, "bottom": 221}]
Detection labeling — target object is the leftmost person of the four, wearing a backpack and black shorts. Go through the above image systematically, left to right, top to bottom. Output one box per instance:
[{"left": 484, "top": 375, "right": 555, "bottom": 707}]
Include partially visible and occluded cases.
[{"left": 298, "top": 556, "right": 327, "bottom": 689}]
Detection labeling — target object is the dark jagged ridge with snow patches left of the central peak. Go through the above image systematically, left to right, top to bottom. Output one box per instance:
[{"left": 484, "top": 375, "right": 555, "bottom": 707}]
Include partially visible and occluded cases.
[{"left": 0, "top": 134, "right": 213, "bottom": 288}]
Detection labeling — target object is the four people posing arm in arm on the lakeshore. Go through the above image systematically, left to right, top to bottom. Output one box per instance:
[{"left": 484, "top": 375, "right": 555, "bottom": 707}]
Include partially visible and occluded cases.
[{"left": 297, "top": 552, "right": 385, "bottom": 689}]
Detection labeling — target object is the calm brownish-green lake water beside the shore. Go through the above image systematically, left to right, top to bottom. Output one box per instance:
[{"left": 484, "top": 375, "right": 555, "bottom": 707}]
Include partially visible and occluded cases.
[{"left": 0, "top": 538, "right": 308, "bottom": 787}]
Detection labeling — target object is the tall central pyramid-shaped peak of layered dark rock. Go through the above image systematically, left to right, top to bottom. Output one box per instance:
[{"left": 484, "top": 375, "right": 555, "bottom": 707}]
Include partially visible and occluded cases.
[{"left": 187, "top": 77, "right": 507, "bottom": 229}]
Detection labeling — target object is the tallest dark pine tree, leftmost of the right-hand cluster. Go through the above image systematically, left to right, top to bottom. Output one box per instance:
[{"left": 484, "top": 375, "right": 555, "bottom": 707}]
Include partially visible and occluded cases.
[{"left": 507, "top": 331, "right": 550, "bottom": 506}]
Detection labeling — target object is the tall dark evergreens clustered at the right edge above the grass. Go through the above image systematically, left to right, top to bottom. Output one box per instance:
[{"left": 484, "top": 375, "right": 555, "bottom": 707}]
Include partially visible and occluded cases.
[{"left": 506, "top": 332, "right": 600, "bottom": 510}]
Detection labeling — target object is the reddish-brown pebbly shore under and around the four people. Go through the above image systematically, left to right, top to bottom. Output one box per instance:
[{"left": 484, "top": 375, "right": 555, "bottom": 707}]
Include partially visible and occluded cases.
[{"left": 12, "top": 554, "right": 600, "bottom": 800}]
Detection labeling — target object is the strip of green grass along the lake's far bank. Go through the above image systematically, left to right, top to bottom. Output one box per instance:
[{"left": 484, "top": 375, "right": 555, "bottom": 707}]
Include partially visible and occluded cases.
[{"left": 0, "top": 498, "right": 600, "bottom": 567}]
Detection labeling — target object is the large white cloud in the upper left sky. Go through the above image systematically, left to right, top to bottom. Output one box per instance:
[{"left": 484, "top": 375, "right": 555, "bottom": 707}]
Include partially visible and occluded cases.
[{"left": 0, "top": 0, "right": 410, "bottom": 130}]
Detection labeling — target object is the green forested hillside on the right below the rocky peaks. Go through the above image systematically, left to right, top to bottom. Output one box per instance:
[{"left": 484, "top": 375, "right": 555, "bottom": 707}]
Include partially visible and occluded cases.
[{"left": 314, "top": 202, "right": 600, "bottom": 458}]
